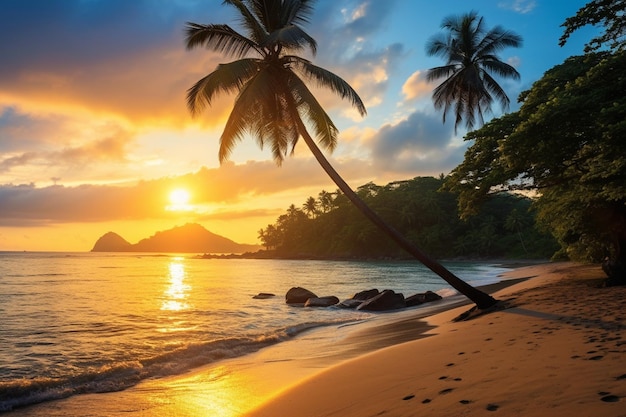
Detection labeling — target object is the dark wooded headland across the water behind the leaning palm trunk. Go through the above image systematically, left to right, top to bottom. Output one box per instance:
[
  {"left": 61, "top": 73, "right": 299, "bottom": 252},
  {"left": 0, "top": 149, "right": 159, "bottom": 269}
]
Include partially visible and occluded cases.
[{"left": 260, "top": 177, "right": 558, "bottom": 258}]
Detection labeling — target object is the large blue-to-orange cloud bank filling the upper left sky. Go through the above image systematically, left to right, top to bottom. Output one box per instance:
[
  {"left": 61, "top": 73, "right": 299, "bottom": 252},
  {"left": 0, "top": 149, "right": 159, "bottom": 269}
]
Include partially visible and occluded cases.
[{"left": 0, "top": 0, "right": 233, "bottom": 125}]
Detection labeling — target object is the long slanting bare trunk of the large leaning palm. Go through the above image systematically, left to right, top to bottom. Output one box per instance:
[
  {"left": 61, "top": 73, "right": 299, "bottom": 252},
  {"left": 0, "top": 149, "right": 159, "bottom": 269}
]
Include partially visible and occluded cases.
[{"left": 297, "top": 118, "right": 497, "bottom": 310}]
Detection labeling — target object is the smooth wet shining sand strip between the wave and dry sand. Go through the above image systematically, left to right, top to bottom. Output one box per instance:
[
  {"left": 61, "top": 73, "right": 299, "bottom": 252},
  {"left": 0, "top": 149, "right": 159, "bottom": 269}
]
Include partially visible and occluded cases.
[{"left": 14, "top": 262, "right": 544, "bottom": 417}]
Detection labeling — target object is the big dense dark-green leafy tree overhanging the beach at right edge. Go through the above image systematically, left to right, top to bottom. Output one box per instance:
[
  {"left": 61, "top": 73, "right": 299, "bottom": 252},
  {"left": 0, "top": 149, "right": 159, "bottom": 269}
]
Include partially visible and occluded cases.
[{"left": 448, "top": 51, "right": 626, "bottom": 277}]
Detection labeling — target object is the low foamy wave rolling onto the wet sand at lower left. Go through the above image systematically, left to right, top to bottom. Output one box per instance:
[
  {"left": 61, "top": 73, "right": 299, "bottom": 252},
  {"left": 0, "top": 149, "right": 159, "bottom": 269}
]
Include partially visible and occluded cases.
[{"left": 0, "top": 319, "right": 354, "bottom": 412}]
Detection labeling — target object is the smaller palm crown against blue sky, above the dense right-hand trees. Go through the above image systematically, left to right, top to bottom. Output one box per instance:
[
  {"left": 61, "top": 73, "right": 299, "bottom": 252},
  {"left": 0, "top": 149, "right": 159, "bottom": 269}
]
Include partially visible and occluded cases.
[{"left": 426, "top": 11, "right": 522, "bottom": 132}]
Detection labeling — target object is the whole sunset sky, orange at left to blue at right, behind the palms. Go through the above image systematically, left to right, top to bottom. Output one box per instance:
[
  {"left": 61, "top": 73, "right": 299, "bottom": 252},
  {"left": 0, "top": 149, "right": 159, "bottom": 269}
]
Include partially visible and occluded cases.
[{"left": 0, "top": 0, "right": 593, "bottom": 251}]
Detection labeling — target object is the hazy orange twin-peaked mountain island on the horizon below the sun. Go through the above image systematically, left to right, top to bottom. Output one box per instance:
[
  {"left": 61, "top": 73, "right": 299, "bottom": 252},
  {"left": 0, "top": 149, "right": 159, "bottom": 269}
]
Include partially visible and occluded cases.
[{"left": 91, "top": 223, "right": 261, "bottom": 253}]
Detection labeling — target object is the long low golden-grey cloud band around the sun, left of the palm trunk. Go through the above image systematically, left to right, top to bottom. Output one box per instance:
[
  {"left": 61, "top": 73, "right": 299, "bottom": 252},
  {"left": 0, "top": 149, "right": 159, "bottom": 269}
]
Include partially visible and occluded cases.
[{"left": 0, "top": 158, "right": 336, "bottom": 226}]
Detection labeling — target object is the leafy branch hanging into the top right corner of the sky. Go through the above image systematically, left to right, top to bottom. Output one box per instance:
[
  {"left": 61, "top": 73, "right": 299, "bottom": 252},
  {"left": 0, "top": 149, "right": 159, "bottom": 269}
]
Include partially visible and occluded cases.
[{"left": 559, "top": 0, "right": 626, "bottom": 52}]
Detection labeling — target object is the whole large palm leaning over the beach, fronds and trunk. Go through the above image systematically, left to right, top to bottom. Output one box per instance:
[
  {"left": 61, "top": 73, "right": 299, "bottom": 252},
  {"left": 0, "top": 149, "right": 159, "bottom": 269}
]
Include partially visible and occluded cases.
[{"left": 186, "top": 0, "right": 496, "bottom": 310}]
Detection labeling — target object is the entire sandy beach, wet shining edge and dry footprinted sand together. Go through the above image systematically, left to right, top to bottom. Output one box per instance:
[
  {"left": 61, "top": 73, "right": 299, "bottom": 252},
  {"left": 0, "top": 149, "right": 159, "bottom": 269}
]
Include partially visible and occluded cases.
[{"left": 15, "top": 263, "right": 626, "bottom": 417}]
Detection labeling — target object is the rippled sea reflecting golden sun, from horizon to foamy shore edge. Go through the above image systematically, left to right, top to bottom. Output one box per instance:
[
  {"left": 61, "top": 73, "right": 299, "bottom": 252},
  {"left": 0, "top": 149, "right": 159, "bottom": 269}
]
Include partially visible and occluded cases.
[{"left": 0, "top": 252, "right": 506, "bottom": 412}]
